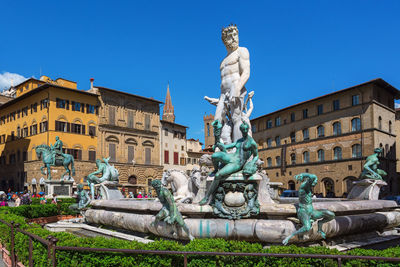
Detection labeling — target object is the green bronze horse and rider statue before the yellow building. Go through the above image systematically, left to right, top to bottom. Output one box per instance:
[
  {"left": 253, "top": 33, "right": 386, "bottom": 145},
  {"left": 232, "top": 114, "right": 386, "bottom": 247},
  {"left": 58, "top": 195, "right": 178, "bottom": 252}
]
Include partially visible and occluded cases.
[{"left": 34, "top": 136, "right": 75, "bottom": 180}]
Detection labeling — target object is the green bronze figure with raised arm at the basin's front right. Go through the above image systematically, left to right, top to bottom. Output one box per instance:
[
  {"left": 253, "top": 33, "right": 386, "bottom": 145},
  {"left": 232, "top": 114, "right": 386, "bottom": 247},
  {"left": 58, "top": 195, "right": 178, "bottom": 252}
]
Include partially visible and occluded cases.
[{"left": 282, "top": 173, "right": 335, "bottom": 245}]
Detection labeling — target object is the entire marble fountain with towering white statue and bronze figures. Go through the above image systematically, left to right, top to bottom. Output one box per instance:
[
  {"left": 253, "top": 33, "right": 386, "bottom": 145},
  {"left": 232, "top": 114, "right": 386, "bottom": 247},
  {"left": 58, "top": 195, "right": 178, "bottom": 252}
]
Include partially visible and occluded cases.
[{"left": 78, "top": 25, "right": 400, "bottom": 247}]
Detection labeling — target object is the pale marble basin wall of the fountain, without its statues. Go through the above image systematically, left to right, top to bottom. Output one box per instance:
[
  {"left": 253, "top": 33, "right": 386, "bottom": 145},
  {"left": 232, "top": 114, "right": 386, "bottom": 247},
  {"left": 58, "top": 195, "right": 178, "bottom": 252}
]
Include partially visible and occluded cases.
[{"left": 85, "top": 199, "right": 400, "bottom": 244}]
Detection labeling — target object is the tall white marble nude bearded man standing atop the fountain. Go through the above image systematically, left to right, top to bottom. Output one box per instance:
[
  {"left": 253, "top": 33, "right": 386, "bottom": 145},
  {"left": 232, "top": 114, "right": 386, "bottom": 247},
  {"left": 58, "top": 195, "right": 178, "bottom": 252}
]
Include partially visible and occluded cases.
[{"left": 205, "top": 25, "right": 252, "bottom": 144}]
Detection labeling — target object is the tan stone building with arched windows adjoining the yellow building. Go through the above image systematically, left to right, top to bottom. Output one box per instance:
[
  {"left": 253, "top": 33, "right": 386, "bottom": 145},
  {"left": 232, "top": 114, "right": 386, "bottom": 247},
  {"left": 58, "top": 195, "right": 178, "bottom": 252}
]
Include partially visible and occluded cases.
[{"left": 89, "top": 86, "right": 163, "bottom": 193}]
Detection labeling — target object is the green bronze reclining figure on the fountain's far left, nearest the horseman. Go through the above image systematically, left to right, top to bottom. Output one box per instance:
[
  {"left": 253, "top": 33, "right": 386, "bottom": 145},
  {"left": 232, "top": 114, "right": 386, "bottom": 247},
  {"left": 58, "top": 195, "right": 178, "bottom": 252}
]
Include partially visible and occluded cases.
[{"left": 87, "top": 158, "right": 119, "bottom": 198}]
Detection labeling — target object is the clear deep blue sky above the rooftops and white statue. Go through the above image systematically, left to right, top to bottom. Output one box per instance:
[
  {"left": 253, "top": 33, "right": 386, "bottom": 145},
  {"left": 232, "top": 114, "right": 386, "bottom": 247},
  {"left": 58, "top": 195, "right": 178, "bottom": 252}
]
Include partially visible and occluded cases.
[{"left": 0, "top": 0, "right": 400, "bottom": 143}]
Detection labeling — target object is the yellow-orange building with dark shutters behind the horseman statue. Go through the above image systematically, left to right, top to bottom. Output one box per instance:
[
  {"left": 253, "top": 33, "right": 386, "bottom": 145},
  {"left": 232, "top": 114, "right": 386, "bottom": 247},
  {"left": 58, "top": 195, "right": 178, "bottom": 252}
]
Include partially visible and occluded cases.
[{"left": 0, "top": 76, "right": 99, "bottom": 191}]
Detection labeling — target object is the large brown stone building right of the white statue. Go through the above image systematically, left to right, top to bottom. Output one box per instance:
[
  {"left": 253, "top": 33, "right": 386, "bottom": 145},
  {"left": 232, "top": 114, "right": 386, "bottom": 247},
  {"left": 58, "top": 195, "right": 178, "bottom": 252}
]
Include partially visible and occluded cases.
[{"left": 251, "top": 79, "right": 400, "bottom": 196}]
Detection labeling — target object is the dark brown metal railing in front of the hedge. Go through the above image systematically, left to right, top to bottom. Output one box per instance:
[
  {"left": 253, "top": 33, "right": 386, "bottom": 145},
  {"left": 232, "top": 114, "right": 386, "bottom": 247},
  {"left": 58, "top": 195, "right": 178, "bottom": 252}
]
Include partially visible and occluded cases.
[{"left": 0, "top": 219, "right": 400, "bottom": 267}]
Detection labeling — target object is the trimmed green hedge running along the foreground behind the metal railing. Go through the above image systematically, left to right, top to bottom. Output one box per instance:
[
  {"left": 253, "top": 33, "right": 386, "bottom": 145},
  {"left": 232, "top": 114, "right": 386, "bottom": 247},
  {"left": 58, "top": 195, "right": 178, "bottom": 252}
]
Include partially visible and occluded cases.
[{"left": 0, "top": 211, "right": 400, "bottom": 267}]
